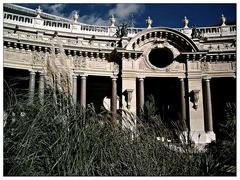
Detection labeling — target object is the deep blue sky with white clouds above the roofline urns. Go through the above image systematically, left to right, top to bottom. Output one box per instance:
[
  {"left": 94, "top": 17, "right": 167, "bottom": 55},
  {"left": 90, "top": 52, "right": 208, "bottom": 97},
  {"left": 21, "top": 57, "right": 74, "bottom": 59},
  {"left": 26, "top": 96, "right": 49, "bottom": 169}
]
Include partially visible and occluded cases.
[{"left": 15, "top": 3, "right": 236, "bottom": 28}]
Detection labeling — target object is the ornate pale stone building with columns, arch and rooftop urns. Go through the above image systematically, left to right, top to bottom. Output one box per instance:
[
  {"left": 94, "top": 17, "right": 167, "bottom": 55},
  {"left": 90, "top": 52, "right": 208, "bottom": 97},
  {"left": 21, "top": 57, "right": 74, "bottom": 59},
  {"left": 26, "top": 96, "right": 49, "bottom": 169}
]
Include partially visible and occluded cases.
[{"left": 3, "top": 4, "right": 236, "bottom": 143}]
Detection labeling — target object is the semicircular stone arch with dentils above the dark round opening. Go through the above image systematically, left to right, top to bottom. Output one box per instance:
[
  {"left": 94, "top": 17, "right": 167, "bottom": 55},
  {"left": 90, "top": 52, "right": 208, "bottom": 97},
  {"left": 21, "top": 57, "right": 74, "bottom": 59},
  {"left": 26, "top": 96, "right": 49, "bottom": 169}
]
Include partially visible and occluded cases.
[{"left": 126, "top": 27, "right": 199, "bottom": 52}]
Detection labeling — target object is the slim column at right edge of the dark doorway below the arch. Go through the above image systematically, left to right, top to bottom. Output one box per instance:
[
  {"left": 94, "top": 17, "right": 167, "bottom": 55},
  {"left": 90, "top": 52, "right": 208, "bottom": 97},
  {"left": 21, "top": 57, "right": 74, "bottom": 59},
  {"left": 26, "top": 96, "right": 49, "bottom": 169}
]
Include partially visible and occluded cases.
[{"left": 179, "top": 78, "right": 187, "bottom": 131}]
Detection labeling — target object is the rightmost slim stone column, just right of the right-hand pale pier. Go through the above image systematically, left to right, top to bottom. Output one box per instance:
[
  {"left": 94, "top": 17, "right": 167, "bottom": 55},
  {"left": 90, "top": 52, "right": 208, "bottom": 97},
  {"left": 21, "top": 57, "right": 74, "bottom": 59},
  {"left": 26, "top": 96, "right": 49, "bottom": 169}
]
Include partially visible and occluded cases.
[{"left": 203, "top": 79, "right": 214, "bottom": 132}]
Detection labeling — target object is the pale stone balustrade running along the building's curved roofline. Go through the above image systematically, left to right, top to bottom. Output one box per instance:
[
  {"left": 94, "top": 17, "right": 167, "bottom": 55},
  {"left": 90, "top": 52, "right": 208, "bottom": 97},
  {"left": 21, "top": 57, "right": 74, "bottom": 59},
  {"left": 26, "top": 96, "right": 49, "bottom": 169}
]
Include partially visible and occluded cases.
[{"left": 4, "top": 12, "right": 237, "bottom": 37}]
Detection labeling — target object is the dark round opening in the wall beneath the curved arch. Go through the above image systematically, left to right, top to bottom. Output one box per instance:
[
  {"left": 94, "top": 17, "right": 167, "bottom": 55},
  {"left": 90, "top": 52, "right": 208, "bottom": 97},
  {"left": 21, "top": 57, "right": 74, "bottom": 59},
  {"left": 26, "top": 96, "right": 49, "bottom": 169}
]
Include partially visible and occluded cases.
[{"left": 149, "top": 48, "right": 173, "bottom": 68}]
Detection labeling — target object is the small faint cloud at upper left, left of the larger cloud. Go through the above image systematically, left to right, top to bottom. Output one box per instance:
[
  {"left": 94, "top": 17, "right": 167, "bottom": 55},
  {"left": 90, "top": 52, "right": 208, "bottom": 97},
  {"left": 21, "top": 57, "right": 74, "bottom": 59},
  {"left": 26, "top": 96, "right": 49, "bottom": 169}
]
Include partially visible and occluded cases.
[{"left": 41, "top": 4, "right": 66, "bottom": 17}]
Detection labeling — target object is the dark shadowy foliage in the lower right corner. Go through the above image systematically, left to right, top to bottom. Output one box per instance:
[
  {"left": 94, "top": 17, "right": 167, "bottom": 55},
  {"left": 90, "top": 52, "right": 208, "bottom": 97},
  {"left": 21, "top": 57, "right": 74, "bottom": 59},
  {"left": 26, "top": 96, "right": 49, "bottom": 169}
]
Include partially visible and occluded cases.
[{"left": 202, "top": 103, "right": 236, "bottom": 176}]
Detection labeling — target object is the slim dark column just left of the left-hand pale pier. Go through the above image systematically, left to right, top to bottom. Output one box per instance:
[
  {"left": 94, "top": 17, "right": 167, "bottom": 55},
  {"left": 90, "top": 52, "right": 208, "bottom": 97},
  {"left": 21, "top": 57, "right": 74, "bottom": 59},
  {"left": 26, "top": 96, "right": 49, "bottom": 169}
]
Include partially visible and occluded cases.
[{"left": 111, "top": 77, "right": 117, "bottom": 122}]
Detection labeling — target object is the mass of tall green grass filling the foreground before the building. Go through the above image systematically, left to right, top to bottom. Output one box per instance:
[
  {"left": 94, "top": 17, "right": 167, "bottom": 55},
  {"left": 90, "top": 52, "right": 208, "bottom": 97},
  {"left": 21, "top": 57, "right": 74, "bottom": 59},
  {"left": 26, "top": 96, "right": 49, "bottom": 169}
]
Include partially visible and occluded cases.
[{"left": 4, "top": 90, "right": 236, "bottom": 176}]
